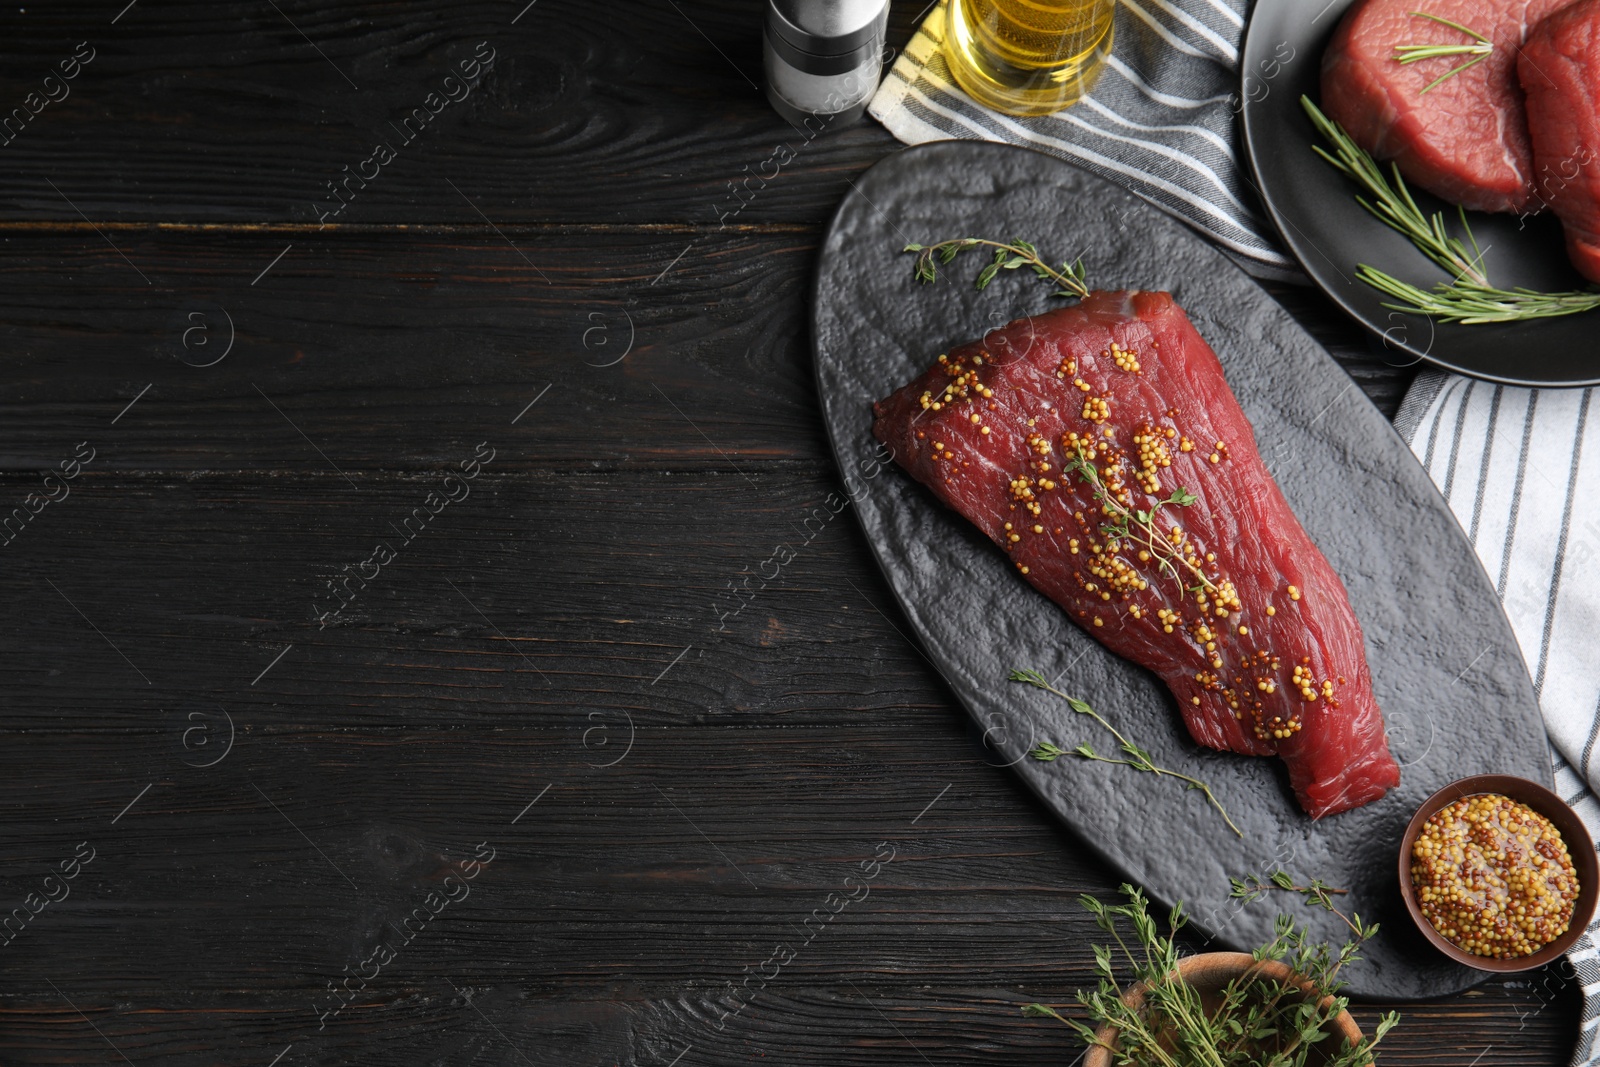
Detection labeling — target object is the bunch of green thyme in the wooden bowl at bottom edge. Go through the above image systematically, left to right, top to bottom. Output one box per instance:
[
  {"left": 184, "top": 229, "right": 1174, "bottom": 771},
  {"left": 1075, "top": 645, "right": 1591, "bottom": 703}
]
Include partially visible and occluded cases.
[{"left": 1022, "top": 885, "right": 1400, "bottom": 1067}]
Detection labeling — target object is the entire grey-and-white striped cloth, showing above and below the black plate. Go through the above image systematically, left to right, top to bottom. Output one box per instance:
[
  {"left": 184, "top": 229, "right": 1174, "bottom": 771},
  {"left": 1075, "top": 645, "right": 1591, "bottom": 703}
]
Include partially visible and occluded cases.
[{"left": 869, "top": 0, "right": 1600, "bottom": 1067}]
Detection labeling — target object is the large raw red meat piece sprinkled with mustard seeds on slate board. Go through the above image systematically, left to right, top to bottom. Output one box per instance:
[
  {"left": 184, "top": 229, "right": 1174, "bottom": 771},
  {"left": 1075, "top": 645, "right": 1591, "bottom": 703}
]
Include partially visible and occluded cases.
[{"left": 874, "top": 291, "right": 1400, "bottom": 817}]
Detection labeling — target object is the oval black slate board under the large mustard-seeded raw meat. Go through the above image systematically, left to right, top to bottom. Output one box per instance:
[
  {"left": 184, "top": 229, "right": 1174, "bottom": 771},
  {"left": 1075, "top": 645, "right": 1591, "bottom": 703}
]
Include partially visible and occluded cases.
[{"left": 814, "top": 141, "right": 1550, "bottom": 998}]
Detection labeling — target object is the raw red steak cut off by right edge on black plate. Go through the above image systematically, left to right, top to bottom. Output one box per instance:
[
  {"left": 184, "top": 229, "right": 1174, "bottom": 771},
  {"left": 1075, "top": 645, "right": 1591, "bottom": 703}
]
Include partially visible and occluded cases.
[{"left": 1517, "top": 0, "right": 1600, "bottom": 282}]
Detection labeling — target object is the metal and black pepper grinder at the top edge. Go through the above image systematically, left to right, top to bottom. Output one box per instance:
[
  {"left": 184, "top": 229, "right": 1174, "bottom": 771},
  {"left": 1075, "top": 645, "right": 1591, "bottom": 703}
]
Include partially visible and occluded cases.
[{"left": 763, "top": 0, "right": 890, "bottom": 134}]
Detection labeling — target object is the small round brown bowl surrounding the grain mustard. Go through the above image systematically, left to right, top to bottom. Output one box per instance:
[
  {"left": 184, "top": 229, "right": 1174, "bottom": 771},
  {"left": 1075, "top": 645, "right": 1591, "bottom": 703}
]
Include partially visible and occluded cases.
[{"left": 1398, "top": 774, "right": 1600, "bottom": 971}]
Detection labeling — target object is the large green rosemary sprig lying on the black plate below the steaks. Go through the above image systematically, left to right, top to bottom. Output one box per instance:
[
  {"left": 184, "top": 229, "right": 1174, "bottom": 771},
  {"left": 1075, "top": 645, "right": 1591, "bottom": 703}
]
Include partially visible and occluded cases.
[{"left": 1301, "top": 96, "right": 1600, "bottom": 325}]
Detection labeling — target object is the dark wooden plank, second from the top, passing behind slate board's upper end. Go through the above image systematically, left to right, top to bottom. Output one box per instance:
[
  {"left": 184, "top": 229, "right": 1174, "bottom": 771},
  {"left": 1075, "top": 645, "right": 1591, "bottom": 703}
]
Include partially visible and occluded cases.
[{"left": 0, "top": 233, "right": 1410, "bottom": 478}]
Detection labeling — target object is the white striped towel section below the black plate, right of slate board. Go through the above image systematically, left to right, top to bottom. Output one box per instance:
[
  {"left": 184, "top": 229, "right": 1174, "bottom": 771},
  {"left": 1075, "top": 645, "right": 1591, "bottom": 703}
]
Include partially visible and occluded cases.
[{"left": 1395, "top": 371, "right": 1600, "bottom": 1067}]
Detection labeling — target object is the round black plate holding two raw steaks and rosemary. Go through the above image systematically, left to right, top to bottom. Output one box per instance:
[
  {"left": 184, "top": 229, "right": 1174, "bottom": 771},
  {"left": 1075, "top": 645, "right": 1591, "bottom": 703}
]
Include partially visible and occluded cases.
[{"left": 1240, "top": 0, "right": 1600, "bottom": 386}]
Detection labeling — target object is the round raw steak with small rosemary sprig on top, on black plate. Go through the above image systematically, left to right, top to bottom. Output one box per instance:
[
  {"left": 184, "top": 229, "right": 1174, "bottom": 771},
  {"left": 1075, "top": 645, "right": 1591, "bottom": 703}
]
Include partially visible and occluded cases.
[{"left": 1322, "top": 0, "right": 1568, "bottom": 211}]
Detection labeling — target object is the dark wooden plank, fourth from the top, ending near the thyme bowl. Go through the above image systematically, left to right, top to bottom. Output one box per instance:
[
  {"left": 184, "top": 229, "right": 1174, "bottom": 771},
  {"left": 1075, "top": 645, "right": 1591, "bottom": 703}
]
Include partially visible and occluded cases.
[{"left": 5, "top": 718, "right": 1196, "bottom": 991}]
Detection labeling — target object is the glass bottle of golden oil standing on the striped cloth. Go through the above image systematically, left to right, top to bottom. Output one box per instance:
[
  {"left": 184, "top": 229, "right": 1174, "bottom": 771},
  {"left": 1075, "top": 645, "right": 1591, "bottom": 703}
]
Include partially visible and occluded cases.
[{"left": 944, "top": 0, "right": 1117, "bottom": 115}]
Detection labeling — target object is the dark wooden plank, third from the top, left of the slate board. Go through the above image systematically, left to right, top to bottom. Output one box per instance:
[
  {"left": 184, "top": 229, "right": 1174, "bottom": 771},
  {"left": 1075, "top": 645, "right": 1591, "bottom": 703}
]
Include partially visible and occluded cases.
[{"left": 0, "top": 470, "right": 944, "bottom": 734}]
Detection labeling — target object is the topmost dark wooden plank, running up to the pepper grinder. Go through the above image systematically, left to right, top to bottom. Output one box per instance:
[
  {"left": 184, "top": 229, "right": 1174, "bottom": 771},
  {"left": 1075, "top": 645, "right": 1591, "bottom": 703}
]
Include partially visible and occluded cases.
[{"left": 0, "top": 0, "right": 920, "bottom": 230}]
